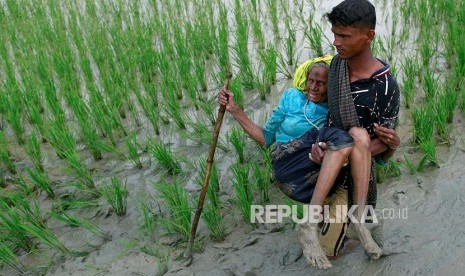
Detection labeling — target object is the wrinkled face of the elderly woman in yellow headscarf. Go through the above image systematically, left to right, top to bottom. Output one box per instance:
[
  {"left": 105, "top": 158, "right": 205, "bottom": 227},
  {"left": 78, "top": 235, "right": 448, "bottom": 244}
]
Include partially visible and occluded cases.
[{"left": 304, "top": 66, "right": 328, "bottom": 103}]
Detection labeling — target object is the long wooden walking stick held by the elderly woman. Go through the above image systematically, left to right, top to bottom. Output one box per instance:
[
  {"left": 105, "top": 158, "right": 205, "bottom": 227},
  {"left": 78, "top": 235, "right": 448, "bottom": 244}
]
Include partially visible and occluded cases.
[{"left": 184, "top": 73, "right": 232, "bottom": 266}]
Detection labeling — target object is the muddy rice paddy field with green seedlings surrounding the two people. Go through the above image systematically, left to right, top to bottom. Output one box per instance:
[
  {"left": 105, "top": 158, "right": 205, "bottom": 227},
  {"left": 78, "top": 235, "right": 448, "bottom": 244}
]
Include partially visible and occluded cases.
[{"left": 0, "top": 0, "right": 465, "bottom": 275}]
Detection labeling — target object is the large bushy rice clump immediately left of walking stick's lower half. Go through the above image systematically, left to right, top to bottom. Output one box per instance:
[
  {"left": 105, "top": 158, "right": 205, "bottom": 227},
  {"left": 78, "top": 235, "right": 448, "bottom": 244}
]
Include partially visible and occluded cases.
[{"left": 154, "top": 179, "right": 191, "bottom": 241}]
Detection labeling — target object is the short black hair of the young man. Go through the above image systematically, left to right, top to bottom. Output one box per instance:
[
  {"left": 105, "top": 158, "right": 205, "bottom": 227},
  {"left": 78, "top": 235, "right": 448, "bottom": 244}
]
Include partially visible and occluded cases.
[{"left": 326, "top": 0, "right": 376, "bottom": 30}]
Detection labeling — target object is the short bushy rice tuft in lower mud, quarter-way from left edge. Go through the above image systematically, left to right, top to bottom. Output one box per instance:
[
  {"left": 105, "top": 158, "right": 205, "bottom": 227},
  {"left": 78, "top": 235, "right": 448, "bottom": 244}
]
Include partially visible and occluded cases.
[{"left": 101, "top": 177, "right": 128, "bottom": 216}]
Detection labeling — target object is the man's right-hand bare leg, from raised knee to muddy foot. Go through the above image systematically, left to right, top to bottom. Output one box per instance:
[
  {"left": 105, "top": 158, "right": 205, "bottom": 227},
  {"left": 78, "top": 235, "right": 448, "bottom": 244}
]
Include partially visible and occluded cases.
[{"left": 349, "top": 127, "right": 382, "bottom": 259}]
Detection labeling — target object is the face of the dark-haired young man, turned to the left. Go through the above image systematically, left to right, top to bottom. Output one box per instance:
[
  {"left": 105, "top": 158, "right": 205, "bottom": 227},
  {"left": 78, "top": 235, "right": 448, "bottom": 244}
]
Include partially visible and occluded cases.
[{"left": 331, "top": 25, "right": 371, "bottom": 59}]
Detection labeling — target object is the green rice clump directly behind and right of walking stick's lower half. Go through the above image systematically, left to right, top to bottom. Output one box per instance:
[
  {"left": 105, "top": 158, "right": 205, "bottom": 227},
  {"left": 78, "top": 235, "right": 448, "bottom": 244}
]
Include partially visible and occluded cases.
[{"left": 195, "top": 158, "right": 225, "bottom": 241}]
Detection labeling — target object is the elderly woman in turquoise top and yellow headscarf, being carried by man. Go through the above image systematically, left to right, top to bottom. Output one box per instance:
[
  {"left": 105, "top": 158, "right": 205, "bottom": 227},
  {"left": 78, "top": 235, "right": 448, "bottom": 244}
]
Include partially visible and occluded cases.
[{"left": 218, "top": 56, "right": 353, "bottom": 204}]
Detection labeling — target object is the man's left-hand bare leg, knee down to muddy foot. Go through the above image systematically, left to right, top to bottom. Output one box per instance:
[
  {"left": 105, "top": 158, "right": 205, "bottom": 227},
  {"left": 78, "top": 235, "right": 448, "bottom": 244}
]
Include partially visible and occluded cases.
[{"left": 299, "top": 147, "right": 352, "bottom": 269}]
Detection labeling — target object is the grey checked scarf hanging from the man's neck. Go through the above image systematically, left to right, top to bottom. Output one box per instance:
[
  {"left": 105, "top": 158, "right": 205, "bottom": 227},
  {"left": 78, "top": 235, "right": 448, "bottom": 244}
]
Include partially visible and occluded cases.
[{"left": 328, "top": 55, "right": 360, "bottom": 131}]
